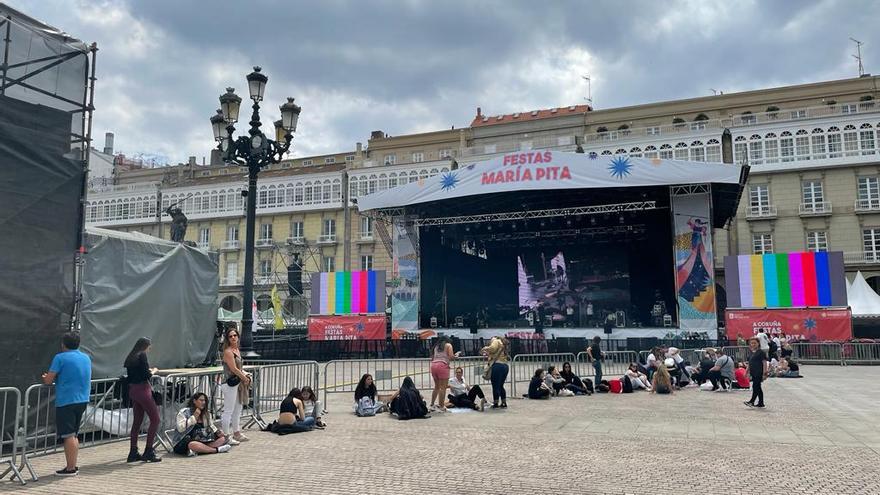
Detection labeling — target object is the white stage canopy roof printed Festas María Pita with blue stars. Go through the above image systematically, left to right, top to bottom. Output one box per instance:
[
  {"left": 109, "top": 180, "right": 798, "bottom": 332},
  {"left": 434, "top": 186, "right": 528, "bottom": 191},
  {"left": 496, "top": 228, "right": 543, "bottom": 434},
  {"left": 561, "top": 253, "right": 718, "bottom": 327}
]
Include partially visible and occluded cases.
[{"left": 358, "top": 151, "right": 745, "bottom": 226}]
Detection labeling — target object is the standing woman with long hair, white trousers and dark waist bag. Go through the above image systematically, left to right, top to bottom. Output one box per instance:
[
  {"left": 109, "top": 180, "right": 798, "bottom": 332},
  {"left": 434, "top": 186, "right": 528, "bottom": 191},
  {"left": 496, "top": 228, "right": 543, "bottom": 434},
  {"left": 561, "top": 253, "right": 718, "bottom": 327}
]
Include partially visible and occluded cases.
[{"left": 220, "top": 326, "right": 251, "bottom": 445}]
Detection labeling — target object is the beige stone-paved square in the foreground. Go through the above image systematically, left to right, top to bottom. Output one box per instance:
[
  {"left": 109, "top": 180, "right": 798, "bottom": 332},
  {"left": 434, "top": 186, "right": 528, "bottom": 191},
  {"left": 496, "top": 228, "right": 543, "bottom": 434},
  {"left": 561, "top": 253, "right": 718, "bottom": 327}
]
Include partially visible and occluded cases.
[{"left": 6, "top": 366, "right": 880, "bottom": 495}]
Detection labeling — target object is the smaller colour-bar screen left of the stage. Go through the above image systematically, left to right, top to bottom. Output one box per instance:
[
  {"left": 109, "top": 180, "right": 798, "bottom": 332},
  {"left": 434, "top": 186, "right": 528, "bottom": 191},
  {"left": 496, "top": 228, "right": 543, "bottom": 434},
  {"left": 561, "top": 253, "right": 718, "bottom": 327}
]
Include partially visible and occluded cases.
[{"left": 310, "top": 271, "right": 385, "bottom": 315}]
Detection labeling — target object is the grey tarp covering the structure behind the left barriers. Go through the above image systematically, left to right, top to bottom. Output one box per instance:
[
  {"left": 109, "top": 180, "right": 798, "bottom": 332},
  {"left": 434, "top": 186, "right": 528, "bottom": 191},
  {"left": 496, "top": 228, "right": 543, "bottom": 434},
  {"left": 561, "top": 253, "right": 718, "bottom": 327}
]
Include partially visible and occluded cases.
[{"left": 81, "top": 228, "right": 219, "bottom": 378}]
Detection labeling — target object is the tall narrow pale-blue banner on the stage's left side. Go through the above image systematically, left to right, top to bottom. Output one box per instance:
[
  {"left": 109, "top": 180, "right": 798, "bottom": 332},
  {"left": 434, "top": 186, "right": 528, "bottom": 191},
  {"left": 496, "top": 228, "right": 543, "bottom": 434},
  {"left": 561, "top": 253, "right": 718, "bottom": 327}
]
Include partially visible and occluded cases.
[{"left": 391, "top": 217, "right": 419, "bottom": 333}]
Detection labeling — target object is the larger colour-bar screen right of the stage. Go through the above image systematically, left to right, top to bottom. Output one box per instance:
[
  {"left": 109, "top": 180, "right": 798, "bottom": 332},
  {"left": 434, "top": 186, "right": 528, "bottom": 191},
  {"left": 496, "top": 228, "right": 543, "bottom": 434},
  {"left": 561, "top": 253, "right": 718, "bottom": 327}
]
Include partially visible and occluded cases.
[{"left": 724, "top": 252, "right": 847, "bottom": 308}]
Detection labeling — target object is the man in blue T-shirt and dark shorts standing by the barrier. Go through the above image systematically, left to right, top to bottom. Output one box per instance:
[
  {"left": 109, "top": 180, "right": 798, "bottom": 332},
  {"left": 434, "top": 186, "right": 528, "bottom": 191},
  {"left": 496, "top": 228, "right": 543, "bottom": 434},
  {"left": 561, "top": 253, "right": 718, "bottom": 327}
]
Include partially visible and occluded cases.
[{"left": 43, "top": 332, "right": 92, "bottom": 476}]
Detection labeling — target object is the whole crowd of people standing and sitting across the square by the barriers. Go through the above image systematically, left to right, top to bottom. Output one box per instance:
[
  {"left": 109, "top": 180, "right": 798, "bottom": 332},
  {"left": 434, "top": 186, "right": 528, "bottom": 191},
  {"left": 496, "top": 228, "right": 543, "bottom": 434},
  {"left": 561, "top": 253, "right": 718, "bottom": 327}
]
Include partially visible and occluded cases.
[{"left": 43, "top": 327, "right": 800, "bottom": 476}]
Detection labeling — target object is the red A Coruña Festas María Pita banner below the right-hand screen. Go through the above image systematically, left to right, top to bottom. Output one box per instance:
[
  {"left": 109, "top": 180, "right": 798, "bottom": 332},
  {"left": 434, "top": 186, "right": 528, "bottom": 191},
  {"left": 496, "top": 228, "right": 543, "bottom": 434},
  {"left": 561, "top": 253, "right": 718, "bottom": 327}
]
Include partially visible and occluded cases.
[{"left": 725, "top": 308, "right": 852, "bottom": 342}]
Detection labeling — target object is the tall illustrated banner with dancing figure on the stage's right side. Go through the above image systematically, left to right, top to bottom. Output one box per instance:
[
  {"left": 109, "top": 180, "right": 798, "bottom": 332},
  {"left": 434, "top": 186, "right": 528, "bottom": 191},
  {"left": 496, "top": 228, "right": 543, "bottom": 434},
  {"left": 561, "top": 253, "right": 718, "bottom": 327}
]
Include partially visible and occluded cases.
[{"left": 672, "top": 193, "right": 718, "bottom": 337}]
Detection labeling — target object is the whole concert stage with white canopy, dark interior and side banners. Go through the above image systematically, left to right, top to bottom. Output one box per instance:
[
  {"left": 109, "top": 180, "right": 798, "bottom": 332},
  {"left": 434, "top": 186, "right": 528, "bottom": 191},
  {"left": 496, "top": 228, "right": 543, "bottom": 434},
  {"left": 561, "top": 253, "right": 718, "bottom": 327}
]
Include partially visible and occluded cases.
[{"left": 358, "top": 150, "right": 748, "bottom": 339}]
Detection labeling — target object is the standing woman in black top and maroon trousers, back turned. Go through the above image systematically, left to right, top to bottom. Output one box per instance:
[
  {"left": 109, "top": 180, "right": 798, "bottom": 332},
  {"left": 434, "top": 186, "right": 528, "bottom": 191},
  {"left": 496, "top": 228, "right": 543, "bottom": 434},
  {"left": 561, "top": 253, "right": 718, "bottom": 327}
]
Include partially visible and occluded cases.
[{"left": 125, "top": 337, "right": 162, "bottom": 462}]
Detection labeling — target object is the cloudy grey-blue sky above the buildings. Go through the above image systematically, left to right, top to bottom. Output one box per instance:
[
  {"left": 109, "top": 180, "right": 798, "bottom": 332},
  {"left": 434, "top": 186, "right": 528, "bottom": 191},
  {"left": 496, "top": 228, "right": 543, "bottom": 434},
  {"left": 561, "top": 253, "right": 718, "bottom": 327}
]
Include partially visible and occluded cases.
[{"left": 2, "top": 0, "right": 880, "bottom": 162}]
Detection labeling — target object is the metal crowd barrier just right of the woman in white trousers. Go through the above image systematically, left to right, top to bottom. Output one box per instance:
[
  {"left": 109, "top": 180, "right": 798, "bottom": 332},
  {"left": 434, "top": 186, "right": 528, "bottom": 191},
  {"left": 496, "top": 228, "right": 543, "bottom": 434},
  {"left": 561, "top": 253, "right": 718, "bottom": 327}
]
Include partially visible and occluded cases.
[{"left": 253, "top": 361, "right": 326, "bottom": 426}]
